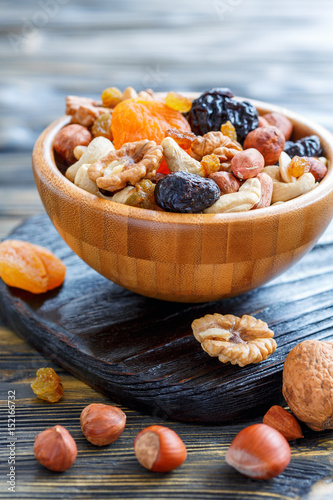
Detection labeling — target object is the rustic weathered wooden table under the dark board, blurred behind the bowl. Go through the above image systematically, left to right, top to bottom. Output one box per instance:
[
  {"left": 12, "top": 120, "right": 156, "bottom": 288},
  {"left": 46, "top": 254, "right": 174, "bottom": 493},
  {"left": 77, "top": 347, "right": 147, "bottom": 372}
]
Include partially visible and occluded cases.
[{"left": 0, "top": 0, "right": 333, "bottom": 500}]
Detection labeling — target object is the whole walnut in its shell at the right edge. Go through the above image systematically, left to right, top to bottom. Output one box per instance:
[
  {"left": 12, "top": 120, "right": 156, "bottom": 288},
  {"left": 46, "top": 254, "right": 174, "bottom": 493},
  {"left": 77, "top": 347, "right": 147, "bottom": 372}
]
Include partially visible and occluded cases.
[{"left": 282, "top": 340, "right": 333, "bottom": 431}]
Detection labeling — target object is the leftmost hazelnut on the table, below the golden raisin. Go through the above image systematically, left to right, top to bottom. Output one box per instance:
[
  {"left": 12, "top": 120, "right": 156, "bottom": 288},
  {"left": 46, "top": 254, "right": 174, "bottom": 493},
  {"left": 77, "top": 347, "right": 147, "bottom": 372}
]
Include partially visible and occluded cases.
[{"left": 34, "top": 425, "right": 77, "bottom": 472}]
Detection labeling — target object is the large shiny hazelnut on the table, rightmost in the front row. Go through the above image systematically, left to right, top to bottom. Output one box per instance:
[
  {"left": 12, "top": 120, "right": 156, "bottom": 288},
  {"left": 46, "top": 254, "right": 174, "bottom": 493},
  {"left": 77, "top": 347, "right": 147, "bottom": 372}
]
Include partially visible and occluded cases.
[{"left": 225, "top": 424, "right": 291, "bottom": 479}]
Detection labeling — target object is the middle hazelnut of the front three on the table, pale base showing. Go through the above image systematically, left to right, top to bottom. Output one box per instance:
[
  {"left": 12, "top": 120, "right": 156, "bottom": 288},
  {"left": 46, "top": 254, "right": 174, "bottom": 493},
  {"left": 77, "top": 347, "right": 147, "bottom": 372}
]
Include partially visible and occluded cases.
[{"left": 134, "top": 425, "right": 187, "bottom": 472}]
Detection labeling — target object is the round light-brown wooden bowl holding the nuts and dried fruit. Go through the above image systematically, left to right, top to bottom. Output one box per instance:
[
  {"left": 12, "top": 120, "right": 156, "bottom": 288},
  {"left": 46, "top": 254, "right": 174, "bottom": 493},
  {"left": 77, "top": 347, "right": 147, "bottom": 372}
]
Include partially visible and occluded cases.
[{"left": 33, "top": 94, "right": 333, "bottom": 302}]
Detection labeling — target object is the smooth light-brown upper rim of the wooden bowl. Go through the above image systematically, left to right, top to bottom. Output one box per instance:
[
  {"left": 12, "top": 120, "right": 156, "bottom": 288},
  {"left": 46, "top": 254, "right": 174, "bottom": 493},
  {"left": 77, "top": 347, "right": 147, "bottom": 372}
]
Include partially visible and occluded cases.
[{"left": 33, "top": 92, "right": 333, "bottom": 225}]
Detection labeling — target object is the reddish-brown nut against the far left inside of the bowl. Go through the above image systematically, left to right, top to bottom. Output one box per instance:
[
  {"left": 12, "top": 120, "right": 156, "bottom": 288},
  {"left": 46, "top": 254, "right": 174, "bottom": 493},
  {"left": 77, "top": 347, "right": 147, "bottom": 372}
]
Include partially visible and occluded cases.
[{"left": 53, "top": 123, "right": 92, "bottom": 165}]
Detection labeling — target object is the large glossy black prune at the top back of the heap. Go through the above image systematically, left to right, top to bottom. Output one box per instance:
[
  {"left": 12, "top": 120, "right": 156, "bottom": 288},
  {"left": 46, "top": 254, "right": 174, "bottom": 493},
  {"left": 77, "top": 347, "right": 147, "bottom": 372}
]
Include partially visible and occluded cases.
[{"left": 187, "top": 89, "right": 259, "bottom": 143}]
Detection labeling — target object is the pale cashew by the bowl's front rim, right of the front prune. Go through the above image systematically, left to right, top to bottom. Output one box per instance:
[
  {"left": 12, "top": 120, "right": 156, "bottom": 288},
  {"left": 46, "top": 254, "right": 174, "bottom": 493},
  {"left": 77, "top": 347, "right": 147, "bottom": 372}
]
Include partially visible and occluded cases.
[{"left": 204, "top": 177, "right": 261, "bottom": 214}]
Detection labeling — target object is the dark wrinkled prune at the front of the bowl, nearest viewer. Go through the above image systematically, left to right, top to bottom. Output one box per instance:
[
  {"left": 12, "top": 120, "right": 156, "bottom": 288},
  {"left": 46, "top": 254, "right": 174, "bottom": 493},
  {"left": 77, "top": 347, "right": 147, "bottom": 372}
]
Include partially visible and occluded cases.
[{"left": 155, "top": 172, "right": 220, "bottom": 213}]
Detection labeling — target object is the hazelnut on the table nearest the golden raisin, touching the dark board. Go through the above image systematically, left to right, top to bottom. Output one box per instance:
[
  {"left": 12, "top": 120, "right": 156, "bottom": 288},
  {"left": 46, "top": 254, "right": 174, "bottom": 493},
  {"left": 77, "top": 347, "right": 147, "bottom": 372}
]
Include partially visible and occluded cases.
[{"left": 80, "top": 403, "right": 126, "bottom": 446}]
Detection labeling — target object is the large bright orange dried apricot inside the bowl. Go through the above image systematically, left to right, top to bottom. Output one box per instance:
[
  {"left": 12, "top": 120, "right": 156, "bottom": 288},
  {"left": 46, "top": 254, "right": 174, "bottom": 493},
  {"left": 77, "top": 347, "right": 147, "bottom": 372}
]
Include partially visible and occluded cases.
[{"left": 111, "top": 99, "right": 191, "bottom": 149}]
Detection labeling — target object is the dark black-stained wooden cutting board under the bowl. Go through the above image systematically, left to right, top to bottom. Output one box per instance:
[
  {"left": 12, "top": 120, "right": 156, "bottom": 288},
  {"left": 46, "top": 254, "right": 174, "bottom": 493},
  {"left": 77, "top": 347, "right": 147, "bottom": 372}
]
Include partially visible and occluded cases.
[{"left": 0, "top": 215, "right": 333, "bottom": 424}]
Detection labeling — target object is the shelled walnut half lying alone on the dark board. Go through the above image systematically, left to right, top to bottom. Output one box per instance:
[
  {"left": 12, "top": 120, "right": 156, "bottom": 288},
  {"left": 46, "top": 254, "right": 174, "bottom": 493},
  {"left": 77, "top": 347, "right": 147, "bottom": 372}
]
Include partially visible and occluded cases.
[{"left": 192, "top": 314, "right": 276, "bottom": 366}]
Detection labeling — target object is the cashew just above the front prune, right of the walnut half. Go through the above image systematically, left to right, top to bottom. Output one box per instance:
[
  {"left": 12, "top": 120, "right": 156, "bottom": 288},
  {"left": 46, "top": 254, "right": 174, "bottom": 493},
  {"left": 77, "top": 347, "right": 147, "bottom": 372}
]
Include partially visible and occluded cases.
[{"left": 161, "top": 137, "right": 205, "bottom": 177}]
